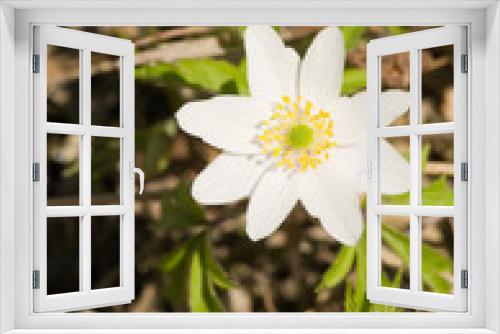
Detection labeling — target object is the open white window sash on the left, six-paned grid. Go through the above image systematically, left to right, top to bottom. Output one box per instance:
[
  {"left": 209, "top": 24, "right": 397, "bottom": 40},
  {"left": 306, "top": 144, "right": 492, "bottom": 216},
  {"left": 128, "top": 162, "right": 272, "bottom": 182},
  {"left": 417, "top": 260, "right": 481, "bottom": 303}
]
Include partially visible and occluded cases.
[{"left": 33, "top": 26, "right": 135, "bottom": 312}]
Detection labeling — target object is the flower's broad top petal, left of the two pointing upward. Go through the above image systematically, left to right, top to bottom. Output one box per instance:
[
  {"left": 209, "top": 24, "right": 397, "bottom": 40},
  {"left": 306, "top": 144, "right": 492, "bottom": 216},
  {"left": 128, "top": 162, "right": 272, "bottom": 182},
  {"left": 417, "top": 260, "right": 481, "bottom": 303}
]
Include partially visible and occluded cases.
[{"left": 245, "top": 26, "right": 300, "bottom": 99}]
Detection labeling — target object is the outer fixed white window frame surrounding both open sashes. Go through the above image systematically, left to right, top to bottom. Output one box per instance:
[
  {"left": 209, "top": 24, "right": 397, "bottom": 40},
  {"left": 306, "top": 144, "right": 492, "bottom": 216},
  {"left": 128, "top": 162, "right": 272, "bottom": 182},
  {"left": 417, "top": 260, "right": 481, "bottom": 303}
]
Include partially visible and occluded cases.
[{"left": 0, "top": 0, "right": 500, "bottom": 333}]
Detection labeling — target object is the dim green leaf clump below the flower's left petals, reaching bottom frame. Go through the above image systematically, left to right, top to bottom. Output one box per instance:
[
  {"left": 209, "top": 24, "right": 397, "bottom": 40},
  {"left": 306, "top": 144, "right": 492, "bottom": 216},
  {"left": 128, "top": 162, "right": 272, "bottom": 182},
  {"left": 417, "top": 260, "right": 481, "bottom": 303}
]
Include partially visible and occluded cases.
[{"left": 160, "top": 182, "right": 234, "bottom": 312}]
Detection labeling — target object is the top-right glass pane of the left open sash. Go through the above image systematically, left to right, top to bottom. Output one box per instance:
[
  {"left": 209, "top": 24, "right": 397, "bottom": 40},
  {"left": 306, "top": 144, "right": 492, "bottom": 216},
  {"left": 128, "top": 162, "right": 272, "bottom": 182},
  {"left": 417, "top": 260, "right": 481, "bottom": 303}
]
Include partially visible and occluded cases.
[{"left": 91, "top": 52, "right": 120, "bottom": 126}]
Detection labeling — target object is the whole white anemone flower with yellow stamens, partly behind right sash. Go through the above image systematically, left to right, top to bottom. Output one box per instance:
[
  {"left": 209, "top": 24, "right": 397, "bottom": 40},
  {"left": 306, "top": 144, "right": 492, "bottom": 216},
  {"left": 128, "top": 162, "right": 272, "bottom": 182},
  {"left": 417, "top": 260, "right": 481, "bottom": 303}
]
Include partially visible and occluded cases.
[{"left": 176, "top": 26, "right": 409, "bottom": 245}]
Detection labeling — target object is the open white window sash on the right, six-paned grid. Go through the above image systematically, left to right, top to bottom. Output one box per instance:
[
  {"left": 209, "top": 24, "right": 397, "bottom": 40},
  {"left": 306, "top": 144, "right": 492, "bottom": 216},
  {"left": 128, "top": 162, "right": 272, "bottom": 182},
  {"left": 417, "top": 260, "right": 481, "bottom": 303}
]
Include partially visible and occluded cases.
[{"left": 366, "top": 26, "right": 470, "bottom": 312}]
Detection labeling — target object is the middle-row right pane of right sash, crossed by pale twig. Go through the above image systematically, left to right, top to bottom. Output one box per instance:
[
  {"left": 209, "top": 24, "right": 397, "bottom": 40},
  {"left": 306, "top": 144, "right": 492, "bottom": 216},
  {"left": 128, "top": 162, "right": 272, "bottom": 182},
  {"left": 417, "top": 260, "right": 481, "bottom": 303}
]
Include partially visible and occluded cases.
[{"left": 421, "top": 134, "right": 454, "bottom": 206}]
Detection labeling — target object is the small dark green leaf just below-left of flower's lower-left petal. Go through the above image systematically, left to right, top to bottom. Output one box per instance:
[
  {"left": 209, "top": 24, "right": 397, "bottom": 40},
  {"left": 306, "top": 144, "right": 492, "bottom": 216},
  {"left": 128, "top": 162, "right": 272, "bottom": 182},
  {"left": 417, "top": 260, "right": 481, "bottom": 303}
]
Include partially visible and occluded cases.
[{"left": 162, "top": 181, "right": 205, "bottom": 228}]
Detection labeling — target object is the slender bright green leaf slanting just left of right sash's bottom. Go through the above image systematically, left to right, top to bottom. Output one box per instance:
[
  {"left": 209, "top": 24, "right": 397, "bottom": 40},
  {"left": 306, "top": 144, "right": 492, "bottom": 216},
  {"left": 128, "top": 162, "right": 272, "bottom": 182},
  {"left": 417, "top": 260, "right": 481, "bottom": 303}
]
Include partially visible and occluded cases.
[{"left": 316, "top": 245, "right": 356, "bottom": 291}]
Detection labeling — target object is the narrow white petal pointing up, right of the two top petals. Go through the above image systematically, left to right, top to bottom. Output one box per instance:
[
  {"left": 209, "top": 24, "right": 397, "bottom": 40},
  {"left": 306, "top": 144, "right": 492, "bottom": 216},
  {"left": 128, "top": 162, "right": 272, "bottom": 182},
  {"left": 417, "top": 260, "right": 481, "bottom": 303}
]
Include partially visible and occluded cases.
[{"left": 300, "top": 27, "right": 344, "bottom": 107}]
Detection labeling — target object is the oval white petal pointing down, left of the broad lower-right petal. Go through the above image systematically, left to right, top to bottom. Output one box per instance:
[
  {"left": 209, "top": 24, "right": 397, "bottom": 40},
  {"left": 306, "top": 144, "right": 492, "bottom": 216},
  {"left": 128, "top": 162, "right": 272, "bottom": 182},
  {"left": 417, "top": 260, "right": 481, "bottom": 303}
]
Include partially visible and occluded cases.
[{"left": 246, "top": 168, "right": 297, "bottom": 241}]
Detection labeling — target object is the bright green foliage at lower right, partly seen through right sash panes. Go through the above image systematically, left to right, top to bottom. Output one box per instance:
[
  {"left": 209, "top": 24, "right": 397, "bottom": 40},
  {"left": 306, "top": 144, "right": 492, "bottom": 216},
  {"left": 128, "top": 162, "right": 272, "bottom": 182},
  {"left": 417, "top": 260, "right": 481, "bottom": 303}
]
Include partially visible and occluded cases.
[{"left": 316, "top": 163, "right": 453, "bottom": 312}]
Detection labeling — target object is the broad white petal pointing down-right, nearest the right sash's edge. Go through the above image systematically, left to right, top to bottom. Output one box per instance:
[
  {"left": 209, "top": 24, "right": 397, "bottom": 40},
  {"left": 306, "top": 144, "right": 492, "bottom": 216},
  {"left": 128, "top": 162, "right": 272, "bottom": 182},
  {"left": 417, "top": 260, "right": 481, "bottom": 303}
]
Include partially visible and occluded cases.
[{"left": 297, "top": 159, "right": 363, "bottom": 245}]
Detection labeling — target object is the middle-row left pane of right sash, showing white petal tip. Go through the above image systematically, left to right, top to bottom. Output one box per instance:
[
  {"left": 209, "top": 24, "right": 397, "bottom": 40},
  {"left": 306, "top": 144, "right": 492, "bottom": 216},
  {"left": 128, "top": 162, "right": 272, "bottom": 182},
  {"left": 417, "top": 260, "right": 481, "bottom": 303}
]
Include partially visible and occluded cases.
[{"left": 379, "top": 137, "right": 410, "bottom": 205}]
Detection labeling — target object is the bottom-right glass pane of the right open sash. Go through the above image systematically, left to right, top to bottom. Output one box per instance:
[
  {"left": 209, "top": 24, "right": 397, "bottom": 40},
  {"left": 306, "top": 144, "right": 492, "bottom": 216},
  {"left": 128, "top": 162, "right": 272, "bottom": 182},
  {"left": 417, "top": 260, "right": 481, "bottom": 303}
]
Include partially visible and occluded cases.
[{"left": 422, "top": 217, "right": 453, "bottom": 294}]
